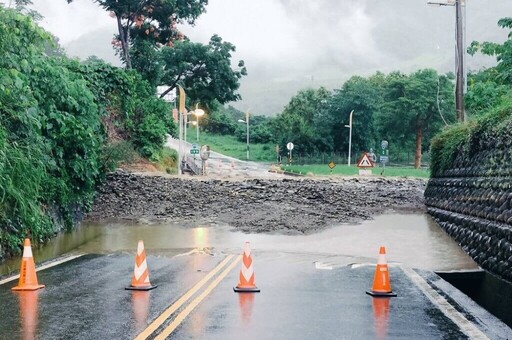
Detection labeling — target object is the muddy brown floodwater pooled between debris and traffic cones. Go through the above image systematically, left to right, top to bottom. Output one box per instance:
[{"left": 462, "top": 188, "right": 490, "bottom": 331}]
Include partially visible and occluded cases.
[{"left": 0, "top": 214, "right": 478, "bottom": 275}]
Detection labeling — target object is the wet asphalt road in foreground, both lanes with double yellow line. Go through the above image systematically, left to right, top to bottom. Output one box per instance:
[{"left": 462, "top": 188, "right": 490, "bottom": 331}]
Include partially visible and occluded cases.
[{"left": 0, "top": 251, "right": 512, "bottom": 339}]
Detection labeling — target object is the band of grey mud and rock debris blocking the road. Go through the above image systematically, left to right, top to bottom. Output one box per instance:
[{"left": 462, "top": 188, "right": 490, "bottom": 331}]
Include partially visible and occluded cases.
[{"left": 87, "top": 171, "right": 426, "bottom": 234}]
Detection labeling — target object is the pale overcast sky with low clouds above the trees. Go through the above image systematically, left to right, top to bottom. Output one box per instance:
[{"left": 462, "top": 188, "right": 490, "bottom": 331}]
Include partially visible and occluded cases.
[{"left": 11, "top": 0, "right": 512, "bottom": 114}]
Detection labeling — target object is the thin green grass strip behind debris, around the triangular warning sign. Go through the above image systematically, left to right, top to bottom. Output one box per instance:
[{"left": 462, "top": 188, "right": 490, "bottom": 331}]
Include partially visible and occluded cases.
[{"left": 281, "top": 164, "right": 430, "bottom": 178}]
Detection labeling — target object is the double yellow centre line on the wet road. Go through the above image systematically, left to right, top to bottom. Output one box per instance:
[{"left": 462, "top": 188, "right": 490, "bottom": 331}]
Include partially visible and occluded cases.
[{"left": 135, "top": 255, "right": 242, "bottom": 340}]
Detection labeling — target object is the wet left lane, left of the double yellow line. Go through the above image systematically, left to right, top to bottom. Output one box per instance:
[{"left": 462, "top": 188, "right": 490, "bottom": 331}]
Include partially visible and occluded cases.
[{"left": 0, "top": 253, "right": 219, "bottom": 339}]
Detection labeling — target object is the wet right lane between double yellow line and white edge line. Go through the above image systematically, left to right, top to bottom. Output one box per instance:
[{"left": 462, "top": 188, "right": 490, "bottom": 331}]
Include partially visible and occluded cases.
[{"left": 173, "top": 256, "right": 466, "bottom": 339}]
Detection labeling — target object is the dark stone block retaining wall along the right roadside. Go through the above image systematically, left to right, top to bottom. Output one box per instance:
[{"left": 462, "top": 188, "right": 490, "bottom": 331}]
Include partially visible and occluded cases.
[{"left": 425, "top": 147, "right": 512, "bottom": 282}]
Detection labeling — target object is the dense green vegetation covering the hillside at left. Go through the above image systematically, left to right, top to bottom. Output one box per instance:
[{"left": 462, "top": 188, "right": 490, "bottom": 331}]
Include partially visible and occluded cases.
[{"left": 0, "top": 6, "right": 175, "bottom": 259}]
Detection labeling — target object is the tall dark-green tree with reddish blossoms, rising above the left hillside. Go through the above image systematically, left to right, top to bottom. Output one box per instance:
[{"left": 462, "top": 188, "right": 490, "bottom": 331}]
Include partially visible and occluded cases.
[{"left": 66, "top": 0, "right": 247, "bottom": 105}]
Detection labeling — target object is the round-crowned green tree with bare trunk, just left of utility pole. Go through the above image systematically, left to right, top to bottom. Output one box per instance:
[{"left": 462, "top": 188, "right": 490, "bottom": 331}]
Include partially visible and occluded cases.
[{"left": 377, "top": 69, "right": 455, "bottom": 168}]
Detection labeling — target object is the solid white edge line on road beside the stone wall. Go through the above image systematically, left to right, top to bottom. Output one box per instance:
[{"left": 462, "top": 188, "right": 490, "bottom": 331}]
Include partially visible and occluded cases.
[{"left": 401, "top": 266, "right": 489, "bottom": 340}]
